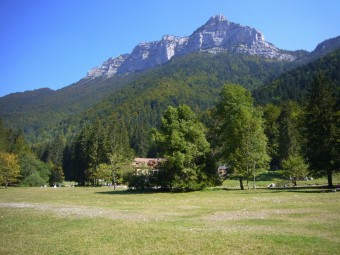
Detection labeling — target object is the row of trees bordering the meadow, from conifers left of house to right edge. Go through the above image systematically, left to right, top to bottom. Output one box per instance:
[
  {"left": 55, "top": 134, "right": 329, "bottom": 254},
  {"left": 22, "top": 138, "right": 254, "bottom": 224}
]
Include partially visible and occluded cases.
[{"left": 62, "top": 73, "right": 340, "bottom": 190}]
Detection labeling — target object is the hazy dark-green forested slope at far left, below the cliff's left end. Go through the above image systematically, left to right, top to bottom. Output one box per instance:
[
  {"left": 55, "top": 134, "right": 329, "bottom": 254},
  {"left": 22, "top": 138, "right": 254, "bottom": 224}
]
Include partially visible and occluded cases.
[{"left": 0, "top": 74, "right": 138, "bottom": 136}]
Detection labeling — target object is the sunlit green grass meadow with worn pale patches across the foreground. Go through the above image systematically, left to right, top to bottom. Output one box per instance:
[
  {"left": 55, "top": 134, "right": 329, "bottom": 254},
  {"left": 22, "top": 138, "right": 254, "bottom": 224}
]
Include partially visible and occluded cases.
[{"left": 0, "top": 187, "right": 340, "bottom": 254}]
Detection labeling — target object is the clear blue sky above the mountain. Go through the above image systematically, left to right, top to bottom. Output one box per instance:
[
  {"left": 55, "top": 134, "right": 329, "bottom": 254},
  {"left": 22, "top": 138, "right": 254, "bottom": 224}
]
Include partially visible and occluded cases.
[{"left": 0, "top": 0, "right": 340, "bottom": 96}]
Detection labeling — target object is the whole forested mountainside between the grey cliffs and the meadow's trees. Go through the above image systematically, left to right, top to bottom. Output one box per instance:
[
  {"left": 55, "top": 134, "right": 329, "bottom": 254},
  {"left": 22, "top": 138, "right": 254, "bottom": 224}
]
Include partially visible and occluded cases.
[{"left": 0, "top": 39, "right": 340, "bottom": 150}]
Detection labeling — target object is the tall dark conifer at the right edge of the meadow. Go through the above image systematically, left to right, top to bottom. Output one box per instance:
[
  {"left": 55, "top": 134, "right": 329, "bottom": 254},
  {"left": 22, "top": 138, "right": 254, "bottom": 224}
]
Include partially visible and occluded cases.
[{"left": 305, "top": 73, "right": 340, "bottom": 187}]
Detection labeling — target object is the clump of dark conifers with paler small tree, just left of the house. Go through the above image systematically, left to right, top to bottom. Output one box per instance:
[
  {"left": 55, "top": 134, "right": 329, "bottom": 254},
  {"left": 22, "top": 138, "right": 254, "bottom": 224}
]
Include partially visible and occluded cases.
[{"left": 64, "top": 117, "right": 134, "bottom": 185}]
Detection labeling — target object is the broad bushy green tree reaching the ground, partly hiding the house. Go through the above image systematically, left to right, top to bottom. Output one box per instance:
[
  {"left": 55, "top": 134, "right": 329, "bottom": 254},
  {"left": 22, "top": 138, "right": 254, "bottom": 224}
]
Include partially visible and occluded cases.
[{"left": 153, "top": 105, "right": 210, "bottom": 191}]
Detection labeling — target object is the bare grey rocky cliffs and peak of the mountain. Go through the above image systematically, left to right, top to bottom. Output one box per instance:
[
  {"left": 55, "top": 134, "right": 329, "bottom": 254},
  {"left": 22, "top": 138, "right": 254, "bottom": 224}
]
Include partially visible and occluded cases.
[{"left": 85, "top": 15, "right": 296, "bottom": 79}]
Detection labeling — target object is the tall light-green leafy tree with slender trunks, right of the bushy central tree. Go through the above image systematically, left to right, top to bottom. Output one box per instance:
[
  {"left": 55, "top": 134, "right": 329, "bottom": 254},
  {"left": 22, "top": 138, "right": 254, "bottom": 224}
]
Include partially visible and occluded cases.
[{"left": 216, "top": 84, "right": 269, "bottom": 189}]
